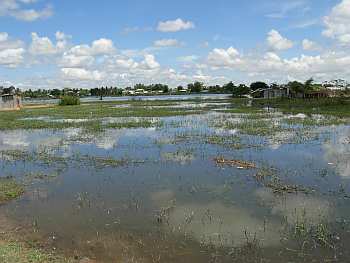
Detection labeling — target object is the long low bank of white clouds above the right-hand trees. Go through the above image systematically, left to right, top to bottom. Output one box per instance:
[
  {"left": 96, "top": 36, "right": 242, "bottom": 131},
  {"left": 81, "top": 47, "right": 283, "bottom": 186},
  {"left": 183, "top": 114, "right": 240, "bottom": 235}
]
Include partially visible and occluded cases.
[{"left": 201, "top": 43, "right": 350, "bottom": 82}]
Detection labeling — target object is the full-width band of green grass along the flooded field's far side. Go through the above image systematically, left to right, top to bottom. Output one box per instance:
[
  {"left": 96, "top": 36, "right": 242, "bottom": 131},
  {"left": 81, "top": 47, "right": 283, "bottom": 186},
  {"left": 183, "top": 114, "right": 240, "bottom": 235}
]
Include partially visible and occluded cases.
[{"left": 0, "top": 98, "right": 350, "bottom": 132}]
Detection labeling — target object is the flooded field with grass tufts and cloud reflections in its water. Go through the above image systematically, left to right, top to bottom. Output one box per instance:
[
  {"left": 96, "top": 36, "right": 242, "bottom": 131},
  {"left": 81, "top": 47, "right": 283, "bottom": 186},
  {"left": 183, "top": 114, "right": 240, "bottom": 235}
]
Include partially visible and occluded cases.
[{"left": 0, "top": 97, "right": 350, "bottom": 263}]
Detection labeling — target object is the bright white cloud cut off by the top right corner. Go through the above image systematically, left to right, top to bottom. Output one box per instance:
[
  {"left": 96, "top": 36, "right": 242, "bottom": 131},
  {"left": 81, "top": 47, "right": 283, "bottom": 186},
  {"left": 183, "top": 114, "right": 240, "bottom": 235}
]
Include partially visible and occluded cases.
[{"left": 322, "top": 0, "right": 350, "bottom": 45}]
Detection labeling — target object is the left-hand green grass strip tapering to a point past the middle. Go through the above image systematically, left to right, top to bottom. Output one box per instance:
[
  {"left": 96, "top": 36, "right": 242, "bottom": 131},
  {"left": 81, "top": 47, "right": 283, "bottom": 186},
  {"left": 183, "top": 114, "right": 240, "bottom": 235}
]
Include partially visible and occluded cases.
[{"left": 0, "top": 102, "right": 202, "bottom": 130}]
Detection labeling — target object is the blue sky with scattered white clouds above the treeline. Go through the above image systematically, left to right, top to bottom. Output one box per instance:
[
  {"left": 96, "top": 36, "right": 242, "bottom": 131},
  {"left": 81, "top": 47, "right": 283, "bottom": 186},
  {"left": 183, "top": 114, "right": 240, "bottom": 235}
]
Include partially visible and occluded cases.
[{"left": 0, "top": 0, "right": 350, "bottom": 89}]
